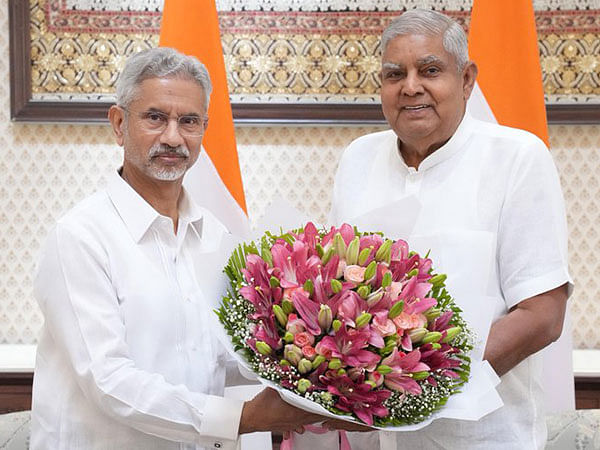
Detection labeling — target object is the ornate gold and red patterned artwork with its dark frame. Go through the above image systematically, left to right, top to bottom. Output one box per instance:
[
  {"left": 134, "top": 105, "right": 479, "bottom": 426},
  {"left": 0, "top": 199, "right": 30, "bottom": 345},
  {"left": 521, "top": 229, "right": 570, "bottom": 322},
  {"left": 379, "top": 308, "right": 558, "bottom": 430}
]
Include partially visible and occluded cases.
[{"left": 9, "top": 0, "right": 600, "bottom": 125}]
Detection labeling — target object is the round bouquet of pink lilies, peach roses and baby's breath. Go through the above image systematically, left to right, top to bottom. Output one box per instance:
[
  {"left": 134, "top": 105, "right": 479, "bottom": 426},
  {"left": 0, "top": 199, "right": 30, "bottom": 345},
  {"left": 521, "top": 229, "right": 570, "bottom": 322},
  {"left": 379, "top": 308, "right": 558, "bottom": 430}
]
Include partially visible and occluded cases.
[{"left": 216, "top": 222, "right": 473, "bottom": 427}]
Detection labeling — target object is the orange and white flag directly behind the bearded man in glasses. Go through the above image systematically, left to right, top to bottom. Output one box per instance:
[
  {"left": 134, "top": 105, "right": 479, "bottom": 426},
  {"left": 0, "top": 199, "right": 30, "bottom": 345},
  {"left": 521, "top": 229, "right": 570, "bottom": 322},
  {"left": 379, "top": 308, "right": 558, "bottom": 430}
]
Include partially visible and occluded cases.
[{"left": 159, "top": 0, "right": 249, "bottom": 237}]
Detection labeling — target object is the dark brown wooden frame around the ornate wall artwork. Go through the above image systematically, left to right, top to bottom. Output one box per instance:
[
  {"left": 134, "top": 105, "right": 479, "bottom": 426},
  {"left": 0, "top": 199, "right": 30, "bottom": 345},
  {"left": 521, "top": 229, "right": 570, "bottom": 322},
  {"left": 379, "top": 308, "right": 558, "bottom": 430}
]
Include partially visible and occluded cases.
[{"left": 8, "top": 0, "right": 600, "bottom": 125}]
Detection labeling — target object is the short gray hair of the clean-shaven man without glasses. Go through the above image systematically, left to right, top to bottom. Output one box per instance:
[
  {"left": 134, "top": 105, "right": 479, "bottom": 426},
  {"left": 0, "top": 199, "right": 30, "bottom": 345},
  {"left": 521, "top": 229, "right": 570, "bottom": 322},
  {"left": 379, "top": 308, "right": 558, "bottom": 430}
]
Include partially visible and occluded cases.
[{"left": 381, "top": 9, "right": 469, "bottom": 70}]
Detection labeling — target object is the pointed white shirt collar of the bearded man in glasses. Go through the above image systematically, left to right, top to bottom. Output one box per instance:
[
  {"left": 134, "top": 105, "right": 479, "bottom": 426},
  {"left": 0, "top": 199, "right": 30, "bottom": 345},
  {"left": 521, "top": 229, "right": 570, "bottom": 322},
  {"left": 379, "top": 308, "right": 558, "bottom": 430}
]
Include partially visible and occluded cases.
[{"left": 106, "top": 171, "right": 202, "bottom": 242}]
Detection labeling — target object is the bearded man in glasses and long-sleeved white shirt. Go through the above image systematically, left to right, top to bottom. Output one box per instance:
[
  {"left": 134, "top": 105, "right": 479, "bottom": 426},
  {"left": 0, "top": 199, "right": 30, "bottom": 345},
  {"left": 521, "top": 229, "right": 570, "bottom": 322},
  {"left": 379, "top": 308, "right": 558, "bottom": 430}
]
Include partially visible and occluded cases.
[{"left": 31, "top": 48, "right": 319, "bottom": 450}]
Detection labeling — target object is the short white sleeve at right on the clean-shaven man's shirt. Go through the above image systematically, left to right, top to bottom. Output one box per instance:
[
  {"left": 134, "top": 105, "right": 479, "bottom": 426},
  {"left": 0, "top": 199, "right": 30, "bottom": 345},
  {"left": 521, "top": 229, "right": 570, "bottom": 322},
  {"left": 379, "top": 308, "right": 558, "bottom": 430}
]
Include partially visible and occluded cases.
[{"left": 498, "top": 135, "right": 572, "bottom": 308}]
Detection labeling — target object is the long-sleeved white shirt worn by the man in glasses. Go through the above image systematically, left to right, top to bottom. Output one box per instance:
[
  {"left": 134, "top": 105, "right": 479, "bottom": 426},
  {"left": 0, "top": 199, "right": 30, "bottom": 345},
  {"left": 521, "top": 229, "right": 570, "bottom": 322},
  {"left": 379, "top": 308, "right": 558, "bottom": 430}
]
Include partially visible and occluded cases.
[{"left": 31, "top": 173, "right": 243, "bottom": 450}]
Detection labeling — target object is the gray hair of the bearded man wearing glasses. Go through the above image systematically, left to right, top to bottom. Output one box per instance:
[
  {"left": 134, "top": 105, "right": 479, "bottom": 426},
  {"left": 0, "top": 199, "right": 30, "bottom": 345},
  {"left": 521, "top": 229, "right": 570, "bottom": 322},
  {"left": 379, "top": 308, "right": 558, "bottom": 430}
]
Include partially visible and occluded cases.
[{"left": 117, "top": 47, "right": 212, "bottom": 108}]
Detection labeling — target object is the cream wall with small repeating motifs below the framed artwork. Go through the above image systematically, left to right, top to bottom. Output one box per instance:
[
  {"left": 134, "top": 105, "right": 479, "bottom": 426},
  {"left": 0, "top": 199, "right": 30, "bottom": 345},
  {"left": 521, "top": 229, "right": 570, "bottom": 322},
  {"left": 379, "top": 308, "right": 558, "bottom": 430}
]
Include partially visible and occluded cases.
[{"left": 0, "top": 5, "right": 600, "bottom": 348}]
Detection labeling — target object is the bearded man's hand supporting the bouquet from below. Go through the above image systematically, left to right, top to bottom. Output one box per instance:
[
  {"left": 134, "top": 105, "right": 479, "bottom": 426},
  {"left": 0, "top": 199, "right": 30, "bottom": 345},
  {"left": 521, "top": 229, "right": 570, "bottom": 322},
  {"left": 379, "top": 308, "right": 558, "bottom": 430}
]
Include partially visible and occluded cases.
[{"left": 239, "top": 388, "right": 325, "bottom": 434}]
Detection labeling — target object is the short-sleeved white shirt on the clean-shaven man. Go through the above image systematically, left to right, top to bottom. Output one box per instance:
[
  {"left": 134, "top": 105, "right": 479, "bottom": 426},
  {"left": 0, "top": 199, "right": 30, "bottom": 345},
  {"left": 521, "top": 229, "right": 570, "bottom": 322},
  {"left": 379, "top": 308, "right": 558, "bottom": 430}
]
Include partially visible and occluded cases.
[{"left": 331, "top": 115, "right": 571, "bottom": 450}]
